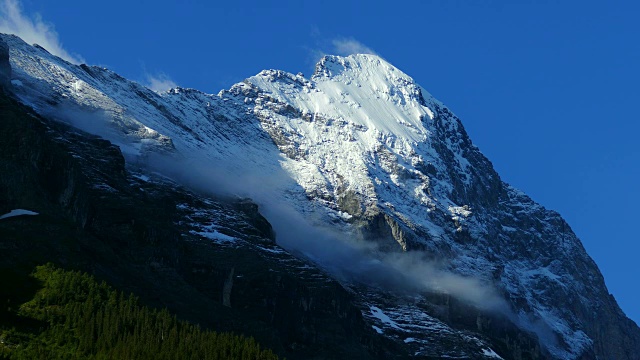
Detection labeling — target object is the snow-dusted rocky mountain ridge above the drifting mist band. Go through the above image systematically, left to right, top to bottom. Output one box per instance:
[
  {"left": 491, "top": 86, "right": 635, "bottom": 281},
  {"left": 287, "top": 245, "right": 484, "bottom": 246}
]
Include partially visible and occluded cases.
[{"left": 3, "top": 32, "right": 640, "bottom": 359}]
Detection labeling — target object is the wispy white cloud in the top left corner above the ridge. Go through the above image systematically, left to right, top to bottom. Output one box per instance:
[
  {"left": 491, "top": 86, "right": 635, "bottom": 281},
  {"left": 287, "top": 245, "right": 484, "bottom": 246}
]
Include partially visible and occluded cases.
[{"left": 0, "top": 0, "right": 84, "bottom": 64}]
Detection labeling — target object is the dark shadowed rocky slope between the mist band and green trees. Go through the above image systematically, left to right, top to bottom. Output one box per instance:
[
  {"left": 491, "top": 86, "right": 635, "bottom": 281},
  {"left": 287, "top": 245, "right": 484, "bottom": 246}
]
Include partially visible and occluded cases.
[{"left": 0, "top": 85, "right": 396, "bottom": 359}]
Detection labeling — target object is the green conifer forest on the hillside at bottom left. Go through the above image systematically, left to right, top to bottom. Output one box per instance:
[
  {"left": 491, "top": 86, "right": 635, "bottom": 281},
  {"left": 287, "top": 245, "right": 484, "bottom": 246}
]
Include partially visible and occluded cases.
[{"left": 0, "top": 264, "right": 277, "bottom": 360}]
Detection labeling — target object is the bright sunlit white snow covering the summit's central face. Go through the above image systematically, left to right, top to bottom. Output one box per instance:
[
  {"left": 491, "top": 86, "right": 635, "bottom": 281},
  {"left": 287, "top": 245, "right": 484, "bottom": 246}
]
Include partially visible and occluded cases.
[{"left": 242, "top": 55, "right": 478, "bottom": 236}]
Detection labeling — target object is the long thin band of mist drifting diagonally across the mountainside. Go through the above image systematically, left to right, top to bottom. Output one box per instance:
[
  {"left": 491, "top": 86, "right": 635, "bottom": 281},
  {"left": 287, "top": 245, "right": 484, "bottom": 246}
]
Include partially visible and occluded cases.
[{"left": 51, "top": 98, "right": 509, "bottom": 313}]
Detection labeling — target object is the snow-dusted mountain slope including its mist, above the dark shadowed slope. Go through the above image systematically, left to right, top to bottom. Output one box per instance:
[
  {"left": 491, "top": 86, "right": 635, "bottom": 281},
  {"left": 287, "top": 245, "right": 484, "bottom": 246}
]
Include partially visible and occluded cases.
[{"left": 2, "top": 32, "right": 640, "bottom": 359}]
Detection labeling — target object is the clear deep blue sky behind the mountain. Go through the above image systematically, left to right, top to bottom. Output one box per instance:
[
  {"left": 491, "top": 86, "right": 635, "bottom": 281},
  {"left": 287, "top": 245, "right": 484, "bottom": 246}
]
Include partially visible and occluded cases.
[{"left": 0, "top": 0, "right": 640, "bottom": 323}]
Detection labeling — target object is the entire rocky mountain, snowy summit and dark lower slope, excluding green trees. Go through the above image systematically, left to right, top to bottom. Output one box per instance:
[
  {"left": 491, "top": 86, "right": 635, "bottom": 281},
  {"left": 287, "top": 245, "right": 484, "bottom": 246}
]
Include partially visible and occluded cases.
[{"left": 0, "top": 35, "right": 640, "bottom": 359}]
